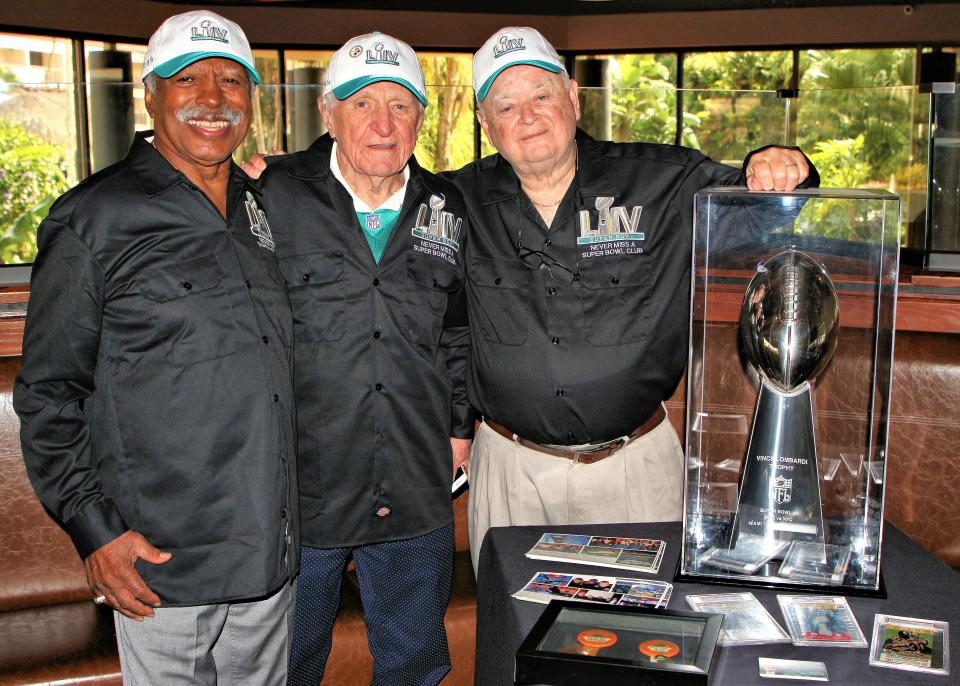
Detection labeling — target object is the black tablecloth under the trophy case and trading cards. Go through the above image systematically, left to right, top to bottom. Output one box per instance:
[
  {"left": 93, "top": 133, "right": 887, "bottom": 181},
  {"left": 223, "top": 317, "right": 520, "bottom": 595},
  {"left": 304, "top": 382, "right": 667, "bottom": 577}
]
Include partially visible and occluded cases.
[{"left": 476, "top": 522, "right": 960, "bottom": 686}]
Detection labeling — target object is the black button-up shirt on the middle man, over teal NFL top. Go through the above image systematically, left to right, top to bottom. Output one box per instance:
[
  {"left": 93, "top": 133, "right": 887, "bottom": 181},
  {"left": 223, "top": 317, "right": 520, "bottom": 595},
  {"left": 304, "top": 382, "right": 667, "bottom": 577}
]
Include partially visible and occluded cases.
[{"left": 261, "top": 136, "right": 473, "bottom": 548}]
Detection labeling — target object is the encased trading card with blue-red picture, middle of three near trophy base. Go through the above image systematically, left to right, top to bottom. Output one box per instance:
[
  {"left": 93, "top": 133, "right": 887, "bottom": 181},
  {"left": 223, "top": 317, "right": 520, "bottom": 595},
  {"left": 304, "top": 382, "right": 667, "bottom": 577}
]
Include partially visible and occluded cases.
[{"left": 777, "top": 595, "right": 867, "bottom": 648}]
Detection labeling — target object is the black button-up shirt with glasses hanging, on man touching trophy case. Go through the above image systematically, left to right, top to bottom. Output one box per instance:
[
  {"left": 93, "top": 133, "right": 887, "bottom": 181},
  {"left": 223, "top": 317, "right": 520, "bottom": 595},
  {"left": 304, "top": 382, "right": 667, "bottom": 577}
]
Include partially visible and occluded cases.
[{"left": 451, "top": 132, "right": 819, "bottom": 445}]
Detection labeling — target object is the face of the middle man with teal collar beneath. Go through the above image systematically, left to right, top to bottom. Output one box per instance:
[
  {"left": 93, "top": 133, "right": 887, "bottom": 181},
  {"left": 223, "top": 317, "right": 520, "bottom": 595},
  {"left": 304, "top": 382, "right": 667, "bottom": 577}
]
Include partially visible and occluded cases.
[{"left": 321, "top": 81, "right": 423, "bottom": 186}]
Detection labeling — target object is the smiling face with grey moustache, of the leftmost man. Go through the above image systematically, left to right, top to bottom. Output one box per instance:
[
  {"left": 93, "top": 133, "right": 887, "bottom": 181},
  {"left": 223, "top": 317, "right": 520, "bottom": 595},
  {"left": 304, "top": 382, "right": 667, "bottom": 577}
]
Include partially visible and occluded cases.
[{"left": 144, "top": 57, "right": 251, "bottom": 179}]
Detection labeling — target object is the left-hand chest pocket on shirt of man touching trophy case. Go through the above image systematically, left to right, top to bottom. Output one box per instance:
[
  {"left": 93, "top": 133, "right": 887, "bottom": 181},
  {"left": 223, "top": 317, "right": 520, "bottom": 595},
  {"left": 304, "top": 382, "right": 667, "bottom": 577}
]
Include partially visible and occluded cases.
[{"left": 469, "top": 257, "right": 533, "bottom": 345}]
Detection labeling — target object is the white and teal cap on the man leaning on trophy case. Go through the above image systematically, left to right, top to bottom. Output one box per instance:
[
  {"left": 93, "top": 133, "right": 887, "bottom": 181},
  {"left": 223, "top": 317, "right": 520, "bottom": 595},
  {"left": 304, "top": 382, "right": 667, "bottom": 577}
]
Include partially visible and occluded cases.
[{"left": 473, "top": 26, "right": 567, "bottom": 102}]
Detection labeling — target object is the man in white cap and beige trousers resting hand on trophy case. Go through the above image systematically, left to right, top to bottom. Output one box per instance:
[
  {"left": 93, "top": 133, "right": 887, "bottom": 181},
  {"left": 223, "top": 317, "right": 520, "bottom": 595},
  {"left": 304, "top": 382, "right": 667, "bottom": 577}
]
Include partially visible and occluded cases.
[{"left": 453, "top": 27, "right": 818, "bottom": 569}]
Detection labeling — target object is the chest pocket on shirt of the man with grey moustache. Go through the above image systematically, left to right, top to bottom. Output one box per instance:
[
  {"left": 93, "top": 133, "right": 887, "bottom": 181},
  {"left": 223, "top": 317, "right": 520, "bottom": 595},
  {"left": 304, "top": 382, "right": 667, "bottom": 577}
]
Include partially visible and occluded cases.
[{"left": 136, "top": 255, "right": 242, "bottom": 365}]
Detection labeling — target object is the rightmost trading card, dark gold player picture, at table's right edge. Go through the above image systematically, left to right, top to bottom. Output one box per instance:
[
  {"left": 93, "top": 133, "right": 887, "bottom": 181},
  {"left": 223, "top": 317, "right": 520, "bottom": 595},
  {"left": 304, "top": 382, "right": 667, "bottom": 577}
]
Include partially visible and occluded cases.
[{"left": 870, "top": 614, "right": 950, "bottom": 674}]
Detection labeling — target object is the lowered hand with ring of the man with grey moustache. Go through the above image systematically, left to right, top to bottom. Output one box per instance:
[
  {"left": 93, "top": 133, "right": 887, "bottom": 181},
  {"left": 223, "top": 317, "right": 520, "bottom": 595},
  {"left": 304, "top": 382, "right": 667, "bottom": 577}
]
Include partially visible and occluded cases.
[{"left": 83, "top": 531, "right": 173, "bottom": 622}]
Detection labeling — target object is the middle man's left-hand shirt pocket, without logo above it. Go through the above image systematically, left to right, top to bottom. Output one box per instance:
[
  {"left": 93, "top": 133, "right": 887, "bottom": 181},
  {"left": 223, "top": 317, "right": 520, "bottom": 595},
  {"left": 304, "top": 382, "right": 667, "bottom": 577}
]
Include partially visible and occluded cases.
[{"left": 280, "top": 251, "right": 346, "bottom": 342}]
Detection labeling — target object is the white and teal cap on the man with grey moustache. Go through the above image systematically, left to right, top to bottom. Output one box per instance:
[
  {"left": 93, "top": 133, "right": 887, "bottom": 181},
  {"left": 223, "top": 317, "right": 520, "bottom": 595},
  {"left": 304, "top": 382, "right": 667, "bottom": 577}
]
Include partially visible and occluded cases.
[{"left": 140, "top": 10, "right": 261, "bottom": 83}]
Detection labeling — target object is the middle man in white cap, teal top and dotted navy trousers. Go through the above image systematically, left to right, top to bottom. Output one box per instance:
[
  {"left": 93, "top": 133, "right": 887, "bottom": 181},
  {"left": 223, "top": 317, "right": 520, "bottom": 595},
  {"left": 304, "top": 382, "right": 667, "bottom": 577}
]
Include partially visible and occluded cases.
[{"left": 261, "top": 33, "right": 473, "bottom": 686}]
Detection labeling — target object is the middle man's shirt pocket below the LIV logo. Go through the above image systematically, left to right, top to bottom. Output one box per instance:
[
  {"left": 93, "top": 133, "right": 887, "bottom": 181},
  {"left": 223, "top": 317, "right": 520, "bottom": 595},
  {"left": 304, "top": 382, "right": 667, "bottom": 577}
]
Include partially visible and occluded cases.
[{"left": 403, "top": 251, "right": 462, "bottom": 358}]
